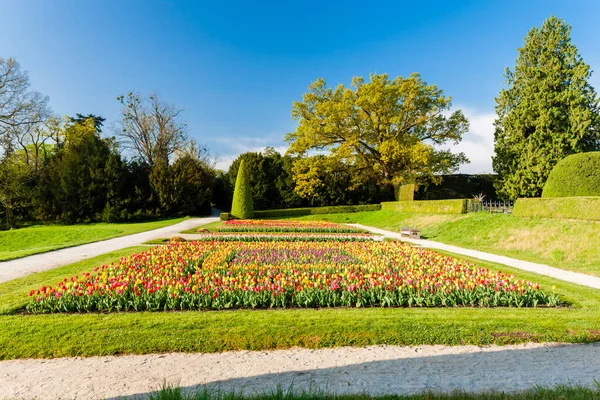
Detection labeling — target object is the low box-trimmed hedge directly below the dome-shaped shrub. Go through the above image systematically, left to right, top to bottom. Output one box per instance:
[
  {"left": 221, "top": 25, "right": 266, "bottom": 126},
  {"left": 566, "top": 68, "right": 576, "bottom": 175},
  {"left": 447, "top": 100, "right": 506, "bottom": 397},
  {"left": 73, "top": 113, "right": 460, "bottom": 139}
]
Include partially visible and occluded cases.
[{"left": 513, "top": 196, "right": 600, "bottom": 221}]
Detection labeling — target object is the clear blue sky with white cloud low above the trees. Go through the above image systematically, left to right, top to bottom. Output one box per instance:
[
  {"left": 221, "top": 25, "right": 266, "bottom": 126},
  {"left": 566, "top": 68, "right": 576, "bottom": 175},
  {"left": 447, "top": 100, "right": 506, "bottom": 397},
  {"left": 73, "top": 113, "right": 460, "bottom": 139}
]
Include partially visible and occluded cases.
[{"left": 0, "top": 0, "right": 600, "bottom": 173}]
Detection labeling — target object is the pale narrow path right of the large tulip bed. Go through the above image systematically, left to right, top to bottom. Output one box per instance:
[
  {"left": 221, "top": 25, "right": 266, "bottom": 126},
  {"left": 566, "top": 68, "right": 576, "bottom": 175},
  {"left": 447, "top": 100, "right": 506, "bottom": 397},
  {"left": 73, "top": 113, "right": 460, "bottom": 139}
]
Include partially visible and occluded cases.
[{"left": 348, "top": 224, "right": 600, "bottom": 289}]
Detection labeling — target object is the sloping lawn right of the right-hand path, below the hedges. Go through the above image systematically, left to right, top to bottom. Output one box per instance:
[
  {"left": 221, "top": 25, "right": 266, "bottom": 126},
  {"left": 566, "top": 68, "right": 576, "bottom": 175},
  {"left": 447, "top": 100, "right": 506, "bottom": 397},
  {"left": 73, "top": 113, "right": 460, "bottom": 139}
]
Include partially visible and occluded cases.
[{"left": 296, "top": 211, "right": 600, "bottom": 276}]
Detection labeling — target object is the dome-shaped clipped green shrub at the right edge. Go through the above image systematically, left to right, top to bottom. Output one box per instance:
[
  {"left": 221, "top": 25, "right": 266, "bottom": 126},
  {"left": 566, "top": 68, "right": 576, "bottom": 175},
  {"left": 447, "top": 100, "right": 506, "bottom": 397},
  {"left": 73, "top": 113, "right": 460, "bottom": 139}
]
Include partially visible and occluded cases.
[{"left": 542, "top": 151, "right": 600, "bottom": 197}]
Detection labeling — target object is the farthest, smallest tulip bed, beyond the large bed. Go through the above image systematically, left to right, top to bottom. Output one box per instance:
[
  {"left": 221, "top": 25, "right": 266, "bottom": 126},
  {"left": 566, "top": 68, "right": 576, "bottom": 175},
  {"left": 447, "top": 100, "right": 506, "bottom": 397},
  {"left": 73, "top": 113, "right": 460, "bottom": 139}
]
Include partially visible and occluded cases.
[{"left": 217, "top": 219, "right": 366, "bottom": 234}]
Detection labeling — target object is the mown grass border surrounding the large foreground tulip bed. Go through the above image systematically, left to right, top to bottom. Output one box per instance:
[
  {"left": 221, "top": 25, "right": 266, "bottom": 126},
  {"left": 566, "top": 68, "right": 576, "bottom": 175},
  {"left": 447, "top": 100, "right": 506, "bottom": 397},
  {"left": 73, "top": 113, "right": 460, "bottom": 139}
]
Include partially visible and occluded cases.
[{"left": 0, "top": 247, "right": 600, "bottom": 360}]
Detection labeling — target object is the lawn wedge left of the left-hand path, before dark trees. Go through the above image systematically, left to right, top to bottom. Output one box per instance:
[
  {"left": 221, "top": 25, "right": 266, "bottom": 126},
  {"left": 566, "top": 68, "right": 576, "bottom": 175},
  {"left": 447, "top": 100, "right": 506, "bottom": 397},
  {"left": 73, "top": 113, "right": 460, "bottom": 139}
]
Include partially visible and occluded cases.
[{"left": 0, "top": 218, "right": 185, "bottom": 261}]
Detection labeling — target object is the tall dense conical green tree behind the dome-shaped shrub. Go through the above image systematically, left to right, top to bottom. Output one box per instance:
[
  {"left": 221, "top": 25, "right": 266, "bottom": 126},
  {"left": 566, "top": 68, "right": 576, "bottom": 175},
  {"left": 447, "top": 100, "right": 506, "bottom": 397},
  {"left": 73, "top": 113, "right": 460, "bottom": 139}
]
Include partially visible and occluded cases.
[{"left": 493, "top": 16, "right": 600, "bottom": 198}]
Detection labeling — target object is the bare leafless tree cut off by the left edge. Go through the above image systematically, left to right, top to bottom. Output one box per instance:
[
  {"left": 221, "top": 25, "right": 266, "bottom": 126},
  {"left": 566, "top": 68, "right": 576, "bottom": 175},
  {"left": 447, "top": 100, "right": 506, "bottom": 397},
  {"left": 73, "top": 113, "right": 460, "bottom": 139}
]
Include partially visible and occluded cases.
[{"left": 0, "top": 58, "right": 50, "bottom": 153}]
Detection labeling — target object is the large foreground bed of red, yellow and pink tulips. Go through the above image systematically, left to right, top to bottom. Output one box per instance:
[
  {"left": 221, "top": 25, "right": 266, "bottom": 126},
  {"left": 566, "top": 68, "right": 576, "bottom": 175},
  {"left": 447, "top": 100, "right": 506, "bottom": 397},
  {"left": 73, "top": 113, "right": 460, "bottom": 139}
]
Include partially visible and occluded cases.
[{"left": 27, "top": 241, "right": 560, "bottom": 313}]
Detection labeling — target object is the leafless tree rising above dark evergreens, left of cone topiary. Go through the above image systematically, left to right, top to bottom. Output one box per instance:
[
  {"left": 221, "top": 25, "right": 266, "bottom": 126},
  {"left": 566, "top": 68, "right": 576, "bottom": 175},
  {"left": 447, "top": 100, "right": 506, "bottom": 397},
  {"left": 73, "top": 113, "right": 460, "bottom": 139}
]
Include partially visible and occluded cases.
[{"left": 115, "top": 93, "right": 187, "bottom": 166}]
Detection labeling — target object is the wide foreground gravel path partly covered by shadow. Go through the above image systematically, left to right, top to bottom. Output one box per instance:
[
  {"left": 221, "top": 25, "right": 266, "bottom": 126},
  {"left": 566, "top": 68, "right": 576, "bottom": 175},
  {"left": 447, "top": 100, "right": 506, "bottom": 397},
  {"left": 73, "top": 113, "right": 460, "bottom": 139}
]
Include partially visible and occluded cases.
[{"left": 0, "top": 344, "right": 600, "bottom": 399}]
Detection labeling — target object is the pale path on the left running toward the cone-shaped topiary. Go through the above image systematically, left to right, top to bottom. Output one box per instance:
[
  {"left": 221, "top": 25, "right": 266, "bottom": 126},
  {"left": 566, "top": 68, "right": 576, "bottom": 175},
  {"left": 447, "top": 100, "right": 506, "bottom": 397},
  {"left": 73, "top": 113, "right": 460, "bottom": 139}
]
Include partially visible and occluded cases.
[{"left": 0, "top": 212, "right": 219, "bottom": 283}]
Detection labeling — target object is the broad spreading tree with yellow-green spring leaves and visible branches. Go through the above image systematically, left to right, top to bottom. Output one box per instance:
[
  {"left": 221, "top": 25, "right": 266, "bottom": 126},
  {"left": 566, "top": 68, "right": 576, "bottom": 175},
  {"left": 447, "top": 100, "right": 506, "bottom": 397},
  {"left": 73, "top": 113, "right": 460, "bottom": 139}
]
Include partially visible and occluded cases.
[{"left": 286, "top": 73, "right": 469, "bottom": 198}]
